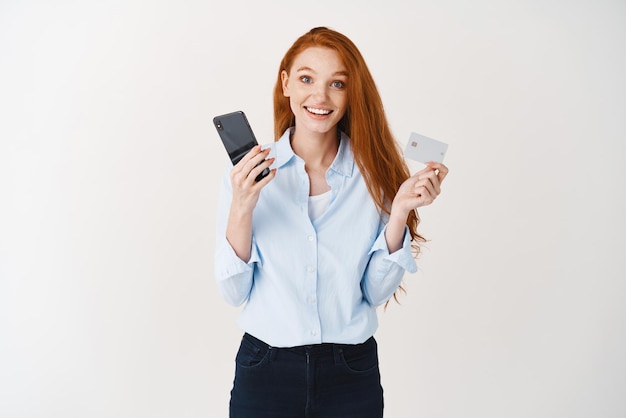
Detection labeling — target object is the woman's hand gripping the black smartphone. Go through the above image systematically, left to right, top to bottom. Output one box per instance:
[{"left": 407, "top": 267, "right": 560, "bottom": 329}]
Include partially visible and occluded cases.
[{"left": 230, "top": 145, "right": 276, "bottom": 213}]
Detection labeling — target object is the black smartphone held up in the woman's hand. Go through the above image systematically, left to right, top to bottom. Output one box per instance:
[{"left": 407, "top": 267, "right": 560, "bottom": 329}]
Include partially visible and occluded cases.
[{"left": 213, "top": 110, "right": 270, "bottom": 181}]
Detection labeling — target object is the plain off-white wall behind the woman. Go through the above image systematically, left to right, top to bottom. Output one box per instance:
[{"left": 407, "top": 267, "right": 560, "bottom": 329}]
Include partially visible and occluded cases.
[{"left": 0, "top": 0, "right": 626, "bottom": 418}]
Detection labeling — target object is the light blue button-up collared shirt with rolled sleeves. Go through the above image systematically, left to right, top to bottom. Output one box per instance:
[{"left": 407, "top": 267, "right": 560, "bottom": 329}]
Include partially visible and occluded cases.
[{"left": 215, "top": 130, "right": 417, "bottom": 347}]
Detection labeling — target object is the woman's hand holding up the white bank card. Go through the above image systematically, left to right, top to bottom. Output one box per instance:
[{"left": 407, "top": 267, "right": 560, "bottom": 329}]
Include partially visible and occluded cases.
[{"left": 391, "top": 162, "right": 448, "bottom": 219}]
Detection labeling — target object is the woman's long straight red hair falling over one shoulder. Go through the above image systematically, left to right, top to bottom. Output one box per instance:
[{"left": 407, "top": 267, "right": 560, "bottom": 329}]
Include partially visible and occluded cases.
[{"left": 274, "top": 27, "right": 425, "bottom": 297}]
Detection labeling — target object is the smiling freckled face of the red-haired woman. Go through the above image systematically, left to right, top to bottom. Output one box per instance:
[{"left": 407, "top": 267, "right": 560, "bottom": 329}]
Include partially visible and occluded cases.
[{"left": 281, "top": 47, "right": 348, "bottom": 134}]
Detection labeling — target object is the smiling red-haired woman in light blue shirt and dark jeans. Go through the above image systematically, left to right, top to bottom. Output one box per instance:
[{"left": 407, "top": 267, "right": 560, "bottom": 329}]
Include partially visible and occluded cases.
[{"left": 215, "top": 27, "right": 448, "bottom": 418}]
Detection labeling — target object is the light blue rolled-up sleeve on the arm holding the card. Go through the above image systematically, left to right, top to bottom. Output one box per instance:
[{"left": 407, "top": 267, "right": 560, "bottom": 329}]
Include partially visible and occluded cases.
[{"left": 361, "top": 227, "right": 417, "bottom": 306}]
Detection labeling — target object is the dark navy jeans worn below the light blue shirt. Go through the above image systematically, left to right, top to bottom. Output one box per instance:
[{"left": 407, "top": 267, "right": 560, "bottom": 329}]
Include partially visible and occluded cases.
[{"left": 230, "top": 334, "right": 383, "bottom": 418}]
